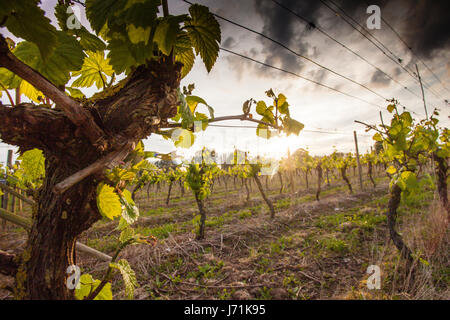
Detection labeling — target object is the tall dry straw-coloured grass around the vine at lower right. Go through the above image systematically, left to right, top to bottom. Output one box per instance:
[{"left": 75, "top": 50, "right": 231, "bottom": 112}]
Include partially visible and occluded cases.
[{"left": 356, "top": 199, "right": 450, "bottom": 300}]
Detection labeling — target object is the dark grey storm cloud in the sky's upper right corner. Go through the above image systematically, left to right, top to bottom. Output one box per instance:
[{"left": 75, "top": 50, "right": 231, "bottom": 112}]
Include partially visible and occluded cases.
[{"left": 254, "top": 0, "right": 450, "bottom": 67}]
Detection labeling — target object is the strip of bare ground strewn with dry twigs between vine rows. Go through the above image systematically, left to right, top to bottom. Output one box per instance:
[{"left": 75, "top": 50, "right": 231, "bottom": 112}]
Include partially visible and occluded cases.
[{"left": 99, "top": 186, "right": 386, "bottom": 299}]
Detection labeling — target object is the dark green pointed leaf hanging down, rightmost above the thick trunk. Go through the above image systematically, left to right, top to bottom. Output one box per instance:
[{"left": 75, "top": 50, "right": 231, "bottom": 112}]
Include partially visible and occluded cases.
[{"left": 184, "top": 4, "right": 221, "bottom": 72}]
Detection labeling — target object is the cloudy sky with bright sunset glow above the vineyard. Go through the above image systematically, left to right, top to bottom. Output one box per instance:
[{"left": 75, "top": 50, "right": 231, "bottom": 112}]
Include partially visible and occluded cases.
[{"left": 0, "top": 0, "right": 450, "bottom": 162}]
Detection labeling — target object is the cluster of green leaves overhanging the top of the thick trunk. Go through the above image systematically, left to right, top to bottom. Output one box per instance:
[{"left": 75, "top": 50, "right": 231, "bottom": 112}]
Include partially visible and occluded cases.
[{"left": 86, "top": 0, "right": 220, "bottom": 77}]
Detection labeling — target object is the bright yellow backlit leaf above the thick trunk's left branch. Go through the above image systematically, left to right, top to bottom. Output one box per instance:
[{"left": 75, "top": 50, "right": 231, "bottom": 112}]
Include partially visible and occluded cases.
[{"left": 72, "top": 51, "right": 114, "bottom": 89}]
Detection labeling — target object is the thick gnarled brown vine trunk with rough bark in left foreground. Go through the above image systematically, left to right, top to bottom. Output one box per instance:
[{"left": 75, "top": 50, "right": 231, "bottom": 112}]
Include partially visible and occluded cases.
[{"left": 0, "top": 57, "right": 182, "bottom": 299}]
